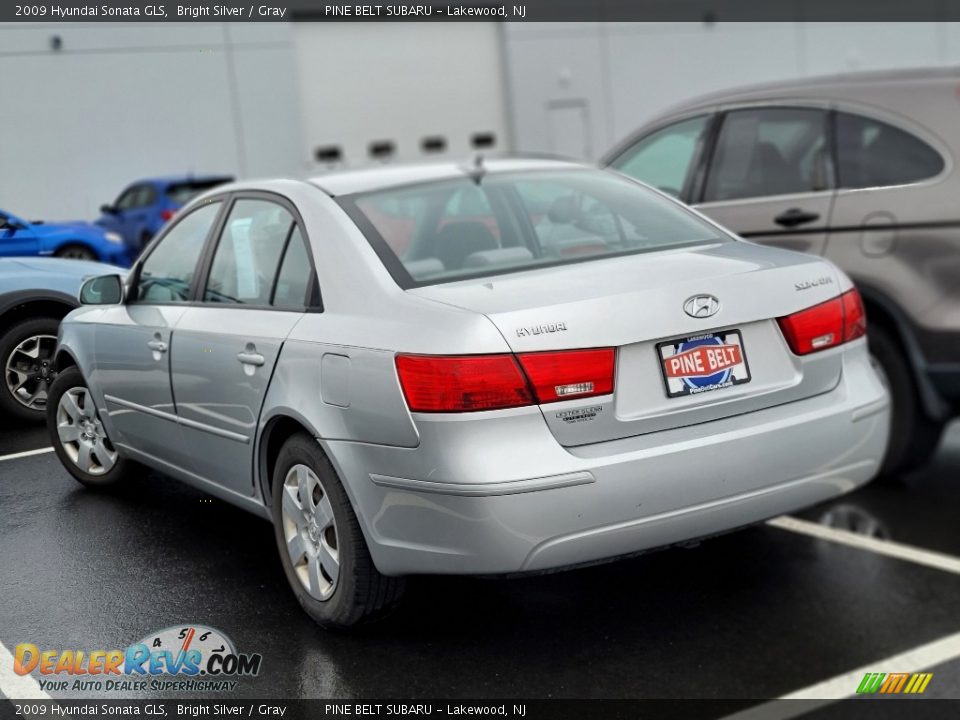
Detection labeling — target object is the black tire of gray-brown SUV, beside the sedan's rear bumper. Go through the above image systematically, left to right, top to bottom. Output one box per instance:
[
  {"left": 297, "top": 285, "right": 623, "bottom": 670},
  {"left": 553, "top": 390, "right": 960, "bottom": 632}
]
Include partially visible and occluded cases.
[{"left": 867, "top": 325, "right": 943, "bottom": 483}]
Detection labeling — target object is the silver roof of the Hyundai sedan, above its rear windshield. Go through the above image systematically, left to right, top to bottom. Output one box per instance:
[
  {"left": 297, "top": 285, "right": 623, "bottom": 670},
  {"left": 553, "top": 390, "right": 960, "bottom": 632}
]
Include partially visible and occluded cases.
[{"left": 308, "top": 158, "right": 588, "bottom": 197}]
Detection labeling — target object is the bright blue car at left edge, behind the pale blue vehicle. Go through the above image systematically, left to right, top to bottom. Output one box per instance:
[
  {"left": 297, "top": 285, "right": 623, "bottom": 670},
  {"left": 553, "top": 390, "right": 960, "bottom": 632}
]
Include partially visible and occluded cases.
[{"left": 0, "top": 210, "right": 131, "bottom": 265}]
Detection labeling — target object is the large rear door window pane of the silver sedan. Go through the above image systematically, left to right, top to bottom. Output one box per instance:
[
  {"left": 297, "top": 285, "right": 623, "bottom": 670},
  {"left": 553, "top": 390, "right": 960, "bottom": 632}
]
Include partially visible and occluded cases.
[{"left": 203, "top": 200, "right": 294, "bottom": 305}]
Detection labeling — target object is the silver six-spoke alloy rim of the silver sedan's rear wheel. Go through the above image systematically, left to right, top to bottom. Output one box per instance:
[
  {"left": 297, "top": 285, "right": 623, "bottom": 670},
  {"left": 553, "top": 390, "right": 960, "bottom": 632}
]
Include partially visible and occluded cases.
[{"left": 281, "top": 465, "right": 340, "bottom": 600}]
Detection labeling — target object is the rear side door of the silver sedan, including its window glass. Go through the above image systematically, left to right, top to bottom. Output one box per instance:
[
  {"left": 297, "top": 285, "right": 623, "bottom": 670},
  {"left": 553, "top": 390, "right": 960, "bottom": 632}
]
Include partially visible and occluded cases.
[{"left": 171, "top": 194, "right": 313, "bottom": 496}]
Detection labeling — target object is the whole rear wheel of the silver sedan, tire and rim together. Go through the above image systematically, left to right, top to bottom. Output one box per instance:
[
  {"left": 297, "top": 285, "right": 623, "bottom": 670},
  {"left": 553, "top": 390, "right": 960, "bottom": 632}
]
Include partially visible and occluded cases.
[{"left": 271, "top": 433, "right": 405, "bottom": 628}]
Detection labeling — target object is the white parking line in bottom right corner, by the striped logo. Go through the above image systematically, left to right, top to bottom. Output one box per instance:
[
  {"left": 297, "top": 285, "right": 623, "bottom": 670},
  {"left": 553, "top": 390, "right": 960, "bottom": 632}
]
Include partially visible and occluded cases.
[{"left": 722, "top": 632, "right": 960, "bottom": 720}]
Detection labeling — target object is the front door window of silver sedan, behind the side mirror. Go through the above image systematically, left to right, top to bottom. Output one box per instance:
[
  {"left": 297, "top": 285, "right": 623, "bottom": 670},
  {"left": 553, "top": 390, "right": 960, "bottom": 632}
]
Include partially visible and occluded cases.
[{"left": 137, "top": 202, "right": 220, "bottom": 303}]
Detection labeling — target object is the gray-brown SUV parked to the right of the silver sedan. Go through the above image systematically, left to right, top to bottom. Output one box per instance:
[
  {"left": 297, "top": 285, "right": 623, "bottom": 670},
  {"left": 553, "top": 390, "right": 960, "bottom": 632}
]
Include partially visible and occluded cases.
[{"left": 603, "top": 69, "right": 960, "bottom": 477}]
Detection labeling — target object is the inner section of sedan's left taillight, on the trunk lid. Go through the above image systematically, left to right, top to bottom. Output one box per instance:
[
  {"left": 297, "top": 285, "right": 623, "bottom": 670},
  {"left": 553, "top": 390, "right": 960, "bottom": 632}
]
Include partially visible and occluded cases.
[{"left": 519, "top": 348, "right": 614, "bottom": 403}]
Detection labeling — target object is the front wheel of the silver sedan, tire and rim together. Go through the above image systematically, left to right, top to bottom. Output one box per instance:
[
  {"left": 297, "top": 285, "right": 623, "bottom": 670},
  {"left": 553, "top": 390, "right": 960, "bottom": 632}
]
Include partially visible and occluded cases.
[{"left": 47, "top": 367, "right": 131, "bottom": 488}]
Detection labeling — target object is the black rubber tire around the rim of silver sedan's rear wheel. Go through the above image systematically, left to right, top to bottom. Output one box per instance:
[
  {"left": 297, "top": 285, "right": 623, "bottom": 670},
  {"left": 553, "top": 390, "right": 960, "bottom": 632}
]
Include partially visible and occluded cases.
[{"left": 271, "top": 435, "right": 363, "bottom": 628}]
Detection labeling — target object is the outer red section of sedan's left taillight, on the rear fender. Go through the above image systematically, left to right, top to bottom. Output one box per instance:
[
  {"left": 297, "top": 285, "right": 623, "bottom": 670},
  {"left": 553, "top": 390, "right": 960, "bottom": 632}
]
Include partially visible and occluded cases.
[{"left": 397, "top": 355, "right": 533, "bottom": 412}]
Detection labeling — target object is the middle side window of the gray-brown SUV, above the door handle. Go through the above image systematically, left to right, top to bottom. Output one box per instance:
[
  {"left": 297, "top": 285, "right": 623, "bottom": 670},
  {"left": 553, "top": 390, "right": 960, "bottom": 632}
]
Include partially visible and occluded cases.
[{"left": 704, "top": 108, "right": 829, "bottom": 202}]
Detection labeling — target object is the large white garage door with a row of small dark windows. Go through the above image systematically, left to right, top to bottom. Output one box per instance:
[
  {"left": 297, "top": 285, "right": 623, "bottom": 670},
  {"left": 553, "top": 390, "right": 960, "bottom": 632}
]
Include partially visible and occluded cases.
[{"left": 294, "top": 23, "right": 511, "bottom": 171}]
